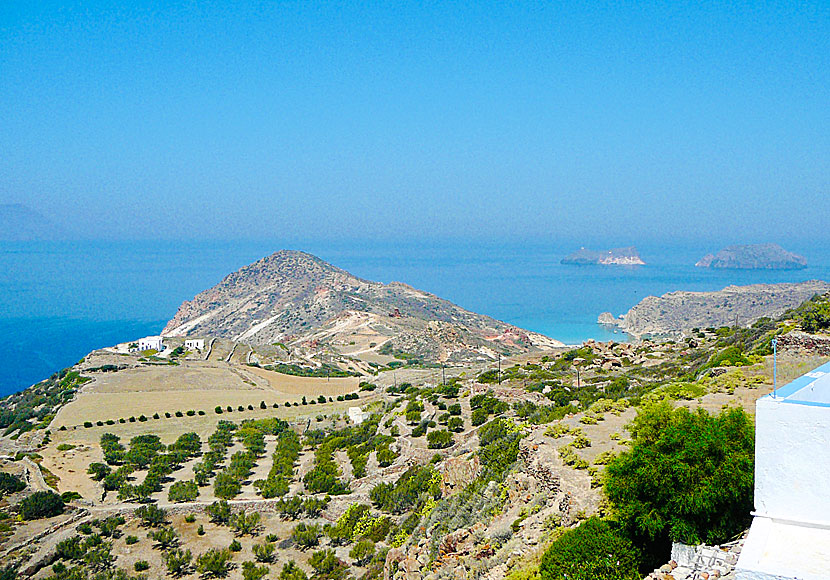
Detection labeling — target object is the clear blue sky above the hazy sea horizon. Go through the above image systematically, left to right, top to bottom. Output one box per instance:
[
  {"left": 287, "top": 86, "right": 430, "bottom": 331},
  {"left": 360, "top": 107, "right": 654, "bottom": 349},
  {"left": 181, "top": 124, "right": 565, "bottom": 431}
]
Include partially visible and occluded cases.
[{"left": 0, "top": 0, "right": 830, "bottom": 243}]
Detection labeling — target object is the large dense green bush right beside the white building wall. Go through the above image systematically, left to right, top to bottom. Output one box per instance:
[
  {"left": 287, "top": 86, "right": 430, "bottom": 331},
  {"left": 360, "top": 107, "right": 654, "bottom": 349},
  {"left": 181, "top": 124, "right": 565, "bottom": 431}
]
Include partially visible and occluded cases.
[{"left": 605, "top": 402, "right": 755, "bottom": 551}]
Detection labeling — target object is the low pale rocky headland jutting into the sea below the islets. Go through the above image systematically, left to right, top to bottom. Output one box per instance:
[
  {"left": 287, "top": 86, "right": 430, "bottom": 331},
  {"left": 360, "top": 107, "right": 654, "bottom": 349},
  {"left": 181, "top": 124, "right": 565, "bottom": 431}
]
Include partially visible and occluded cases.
[{"left": 606, "top": 280, "right": 830, "bottom": 336}]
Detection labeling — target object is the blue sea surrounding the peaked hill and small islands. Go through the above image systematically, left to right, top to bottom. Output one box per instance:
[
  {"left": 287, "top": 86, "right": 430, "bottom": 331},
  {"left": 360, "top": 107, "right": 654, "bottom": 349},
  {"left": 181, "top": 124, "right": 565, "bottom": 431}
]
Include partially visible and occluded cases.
[{"left": 0, "top": 239, "right": 830, "bottom": 396}]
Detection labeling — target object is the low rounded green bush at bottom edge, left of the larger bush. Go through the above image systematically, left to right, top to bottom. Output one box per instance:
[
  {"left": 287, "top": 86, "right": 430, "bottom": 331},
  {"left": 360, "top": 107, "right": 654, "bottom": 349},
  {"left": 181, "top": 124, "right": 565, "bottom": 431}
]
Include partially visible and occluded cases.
[{"left": 539, "top": 517, "right": 641, "bottom": 580}]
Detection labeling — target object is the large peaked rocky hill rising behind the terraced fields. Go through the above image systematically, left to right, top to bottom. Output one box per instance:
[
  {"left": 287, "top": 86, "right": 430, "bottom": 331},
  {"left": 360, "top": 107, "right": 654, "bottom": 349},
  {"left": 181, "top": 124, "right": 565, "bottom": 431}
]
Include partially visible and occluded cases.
[{"left": 163, "top": 250, "right": 561, "bottom": 360}]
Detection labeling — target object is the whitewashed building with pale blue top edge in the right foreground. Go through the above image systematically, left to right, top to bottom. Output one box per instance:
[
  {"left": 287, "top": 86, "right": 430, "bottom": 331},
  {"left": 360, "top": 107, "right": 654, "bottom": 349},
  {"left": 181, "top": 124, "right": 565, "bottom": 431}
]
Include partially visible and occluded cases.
[{"left": 735, "top": 363, "right": 830, "bottom": 580}]
